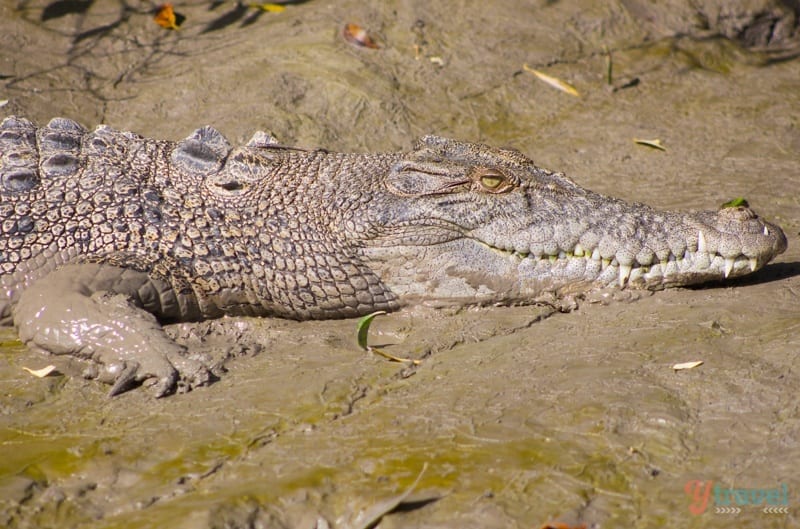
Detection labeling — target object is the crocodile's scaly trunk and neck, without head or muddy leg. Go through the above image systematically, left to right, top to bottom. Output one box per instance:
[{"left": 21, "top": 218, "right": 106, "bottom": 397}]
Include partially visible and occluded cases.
[{"left": 0, "top": 117, "right": 396, "bottom": 321}]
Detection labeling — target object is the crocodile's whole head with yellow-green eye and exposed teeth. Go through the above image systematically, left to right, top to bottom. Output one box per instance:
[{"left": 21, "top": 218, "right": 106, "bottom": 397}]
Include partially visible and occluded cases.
[{"left": 360, "top": 136, "right": 786, "bottom": 304}]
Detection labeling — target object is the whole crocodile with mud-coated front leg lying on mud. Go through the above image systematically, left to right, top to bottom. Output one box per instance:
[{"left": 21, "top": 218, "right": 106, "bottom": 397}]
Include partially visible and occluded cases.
[{"left": 0, "top": 116, "right": 786, "bottom": 396}]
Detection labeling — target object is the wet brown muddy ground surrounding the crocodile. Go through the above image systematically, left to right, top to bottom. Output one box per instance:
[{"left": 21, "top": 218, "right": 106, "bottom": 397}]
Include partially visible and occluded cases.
[{"left": 0, "top": 0, "right": 800, "bottom": 529}]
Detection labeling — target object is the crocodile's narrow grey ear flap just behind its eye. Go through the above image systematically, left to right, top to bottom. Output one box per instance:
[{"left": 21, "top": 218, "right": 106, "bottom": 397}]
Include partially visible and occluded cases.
[{"left": 386, "top": 160, "right": 470, "bottom": 197}]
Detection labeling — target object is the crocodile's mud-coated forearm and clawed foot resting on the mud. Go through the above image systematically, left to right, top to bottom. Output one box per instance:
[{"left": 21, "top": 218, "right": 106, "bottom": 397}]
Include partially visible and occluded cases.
[{"left": 14, "top": 272, "right": 217, "bottom": 397}]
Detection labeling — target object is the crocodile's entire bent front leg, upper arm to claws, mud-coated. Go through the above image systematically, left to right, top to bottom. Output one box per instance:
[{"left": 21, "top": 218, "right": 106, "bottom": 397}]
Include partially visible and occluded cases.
[{"left": 13, "top": 264, "right": 212, "bottom": 397}]
